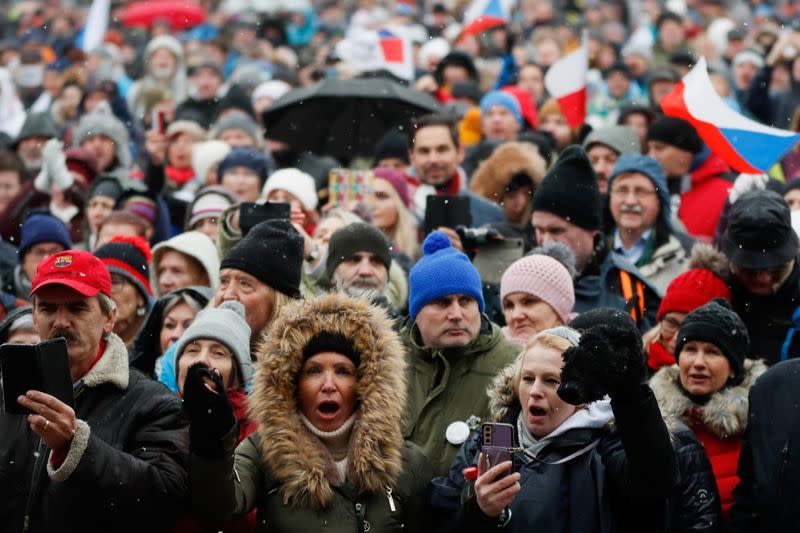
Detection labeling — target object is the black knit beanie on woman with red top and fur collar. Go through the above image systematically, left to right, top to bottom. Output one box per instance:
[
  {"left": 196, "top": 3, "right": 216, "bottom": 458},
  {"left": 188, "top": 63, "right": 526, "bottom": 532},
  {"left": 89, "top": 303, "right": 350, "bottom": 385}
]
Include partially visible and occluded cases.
[{"left": 675, "top": 298, "right": 750, "bottom": 385}]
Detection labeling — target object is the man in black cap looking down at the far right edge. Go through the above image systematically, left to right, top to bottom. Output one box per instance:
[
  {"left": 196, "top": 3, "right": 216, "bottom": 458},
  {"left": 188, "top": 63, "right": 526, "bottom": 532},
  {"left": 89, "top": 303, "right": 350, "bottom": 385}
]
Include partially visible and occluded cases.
[{"left": 721, "top": 190, "right": 800, "bottom": 364}]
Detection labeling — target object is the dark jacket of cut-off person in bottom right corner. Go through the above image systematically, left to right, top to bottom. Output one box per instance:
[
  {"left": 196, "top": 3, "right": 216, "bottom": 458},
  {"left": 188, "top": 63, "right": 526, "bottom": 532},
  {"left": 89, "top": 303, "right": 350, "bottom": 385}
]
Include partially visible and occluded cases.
[{"left": 728, "top": 359, "right": 800, "bottom": 533}]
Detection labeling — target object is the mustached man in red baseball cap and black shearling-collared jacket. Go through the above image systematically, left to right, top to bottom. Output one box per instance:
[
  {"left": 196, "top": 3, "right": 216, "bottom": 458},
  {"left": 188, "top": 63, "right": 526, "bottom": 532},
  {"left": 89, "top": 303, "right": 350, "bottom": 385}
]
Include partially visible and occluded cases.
[{"left": 0, "top": 250, "right": 188, "bottom": 531}]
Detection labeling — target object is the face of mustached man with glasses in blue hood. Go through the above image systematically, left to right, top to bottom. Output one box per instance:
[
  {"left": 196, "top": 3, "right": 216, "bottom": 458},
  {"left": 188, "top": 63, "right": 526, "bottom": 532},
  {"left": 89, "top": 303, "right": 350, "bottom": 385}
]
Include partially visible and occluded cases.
[{"left": 609, "top": 172, "right": 661, "bottom": 235}]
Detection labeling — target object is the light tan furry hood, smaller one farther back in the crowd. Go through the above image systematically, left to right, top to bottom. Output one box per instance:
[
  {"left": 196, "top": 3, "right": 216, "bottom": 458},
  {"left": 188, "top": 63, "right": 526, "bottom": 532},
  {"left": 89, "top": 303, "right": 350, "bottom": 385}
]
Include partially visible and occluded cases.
[{"left": 470, "top": 142, "right": 546, "bottom": 204}]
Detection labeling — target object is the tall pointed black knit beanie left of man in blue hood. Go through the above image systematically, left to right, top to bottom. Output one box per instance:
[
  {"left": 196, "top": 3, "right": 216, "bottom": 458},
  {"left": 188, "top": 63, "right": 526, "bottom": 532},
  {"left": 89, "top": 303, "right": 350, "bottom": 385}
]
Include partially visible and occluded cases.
[{"left": 533, "top": 145, "right": 600, "bottom": 231}]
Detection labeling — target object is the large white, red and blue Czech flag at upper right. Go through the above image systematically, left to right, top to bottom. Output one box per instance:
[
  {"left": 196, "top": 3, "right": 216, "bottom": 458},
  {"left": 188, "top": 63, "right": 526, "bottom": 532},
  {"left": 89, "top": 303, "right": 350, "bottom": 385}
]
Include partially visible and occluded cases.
[{"left": 660, "top": 58, "right": 800, "bottom": 174}]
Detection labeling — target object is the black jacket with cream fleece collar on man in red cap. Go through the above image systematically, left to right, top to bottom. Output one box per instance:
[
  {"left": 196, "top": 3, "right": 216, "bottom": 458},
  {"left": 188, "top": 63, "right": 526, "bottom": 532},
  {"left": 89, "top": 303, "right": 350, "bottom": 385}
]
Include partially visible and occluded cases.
[{"left": 0, "top": 334, "right": 189, "bottom": 533}]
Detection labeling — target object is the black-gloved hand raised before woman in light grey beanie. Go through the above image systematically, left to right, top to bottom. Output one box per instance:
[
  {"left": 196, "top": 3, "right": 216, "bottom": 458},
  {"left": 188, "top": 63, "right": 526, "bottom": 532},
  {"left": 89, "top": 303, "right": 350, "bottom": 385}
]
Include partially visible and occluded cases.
[{"left": 183, "top": 363, "right": 236, "bottom": 457}]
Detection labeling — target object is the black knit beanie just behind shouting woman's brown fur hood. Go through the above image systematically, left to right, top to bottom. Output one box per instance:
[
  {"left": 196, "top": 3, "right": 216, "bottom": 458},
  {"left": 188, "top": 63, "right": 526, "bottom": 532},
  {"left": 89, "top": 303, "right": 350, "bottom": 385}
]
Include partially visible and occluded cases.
[{"left": 219, "top": 220, "right": 303, "bottom": 298}]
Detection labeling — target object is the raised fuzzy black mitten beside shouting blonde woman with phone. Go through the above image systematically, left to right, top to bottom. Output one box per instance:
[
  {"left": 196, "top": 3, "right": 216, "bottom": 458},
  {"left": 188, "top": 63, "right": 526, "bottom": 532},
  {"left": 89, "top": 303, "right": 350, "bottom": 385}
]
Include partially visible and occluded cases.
[{"left": 558, "top": 325, "right": 644, "bottom": 405}]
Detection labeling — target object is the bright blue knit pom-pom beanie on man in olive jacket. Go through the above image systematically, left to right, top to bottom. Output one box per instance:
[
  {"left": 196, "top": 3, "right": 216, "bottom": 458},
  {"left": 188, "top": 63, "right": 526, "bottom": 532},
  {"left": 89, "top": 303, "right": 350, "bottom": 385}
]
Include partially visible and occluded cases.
[{"left": 408, "top": 231, "right": 486, "bottom": 320}]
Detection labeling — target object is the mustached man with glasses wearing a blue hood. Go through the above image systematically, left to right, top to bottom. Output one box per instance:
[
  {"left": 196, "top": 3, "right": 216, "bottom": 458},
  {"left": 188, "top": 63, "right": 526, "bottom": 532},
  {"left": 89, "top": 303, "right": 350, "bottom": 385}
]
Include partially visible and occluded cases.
[{"left": 608, "top": 154, "right": 691, "bottom": 295}]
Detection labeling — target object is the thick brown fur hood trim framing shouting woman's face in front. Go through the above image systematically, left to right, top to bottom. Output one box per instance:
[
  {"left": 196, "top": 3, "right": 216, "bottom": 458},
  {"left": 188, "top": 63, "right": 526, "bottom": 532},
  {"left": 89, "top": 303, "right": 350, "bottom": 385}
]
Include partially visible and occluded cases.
[{"left": 250, "top": 294, "right": 406, "bottom": 509}]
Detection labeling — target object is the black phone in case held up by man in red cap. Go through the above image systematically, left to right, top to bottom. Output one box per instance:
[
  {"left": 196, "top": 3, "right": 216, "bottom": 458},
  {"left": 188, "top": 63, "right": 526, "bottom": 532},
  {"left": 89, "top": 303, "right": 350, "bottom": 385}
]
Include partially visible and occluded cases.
[{"left": 0, "top": 337, "right": 75, "bottom": 415}]
